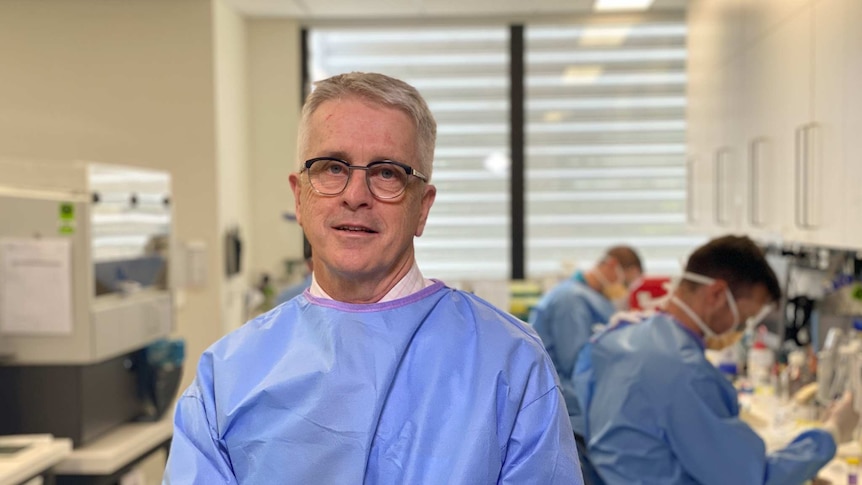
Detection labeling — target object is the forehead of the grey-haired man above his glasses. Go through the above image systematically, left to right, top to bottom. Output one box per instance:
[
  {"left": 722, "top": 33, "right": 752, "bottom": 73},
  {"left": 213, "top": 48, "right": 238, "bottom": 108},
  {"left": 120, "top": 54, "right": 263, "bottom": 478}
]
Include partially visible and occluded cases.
[{"left": 307, "top": 97, "right": 417, "bottom": 161}]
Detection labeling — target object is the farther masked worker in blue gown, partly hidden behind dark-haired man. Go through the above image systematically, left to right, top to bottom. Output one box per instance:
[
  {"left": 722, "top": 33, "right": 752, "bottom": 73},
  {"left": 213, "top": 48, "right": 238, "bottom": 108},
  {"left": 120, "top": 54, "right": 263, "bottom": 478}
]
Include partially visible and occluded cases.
[{"left": 529, "top": 245, "right": 643, "bottom": 483}]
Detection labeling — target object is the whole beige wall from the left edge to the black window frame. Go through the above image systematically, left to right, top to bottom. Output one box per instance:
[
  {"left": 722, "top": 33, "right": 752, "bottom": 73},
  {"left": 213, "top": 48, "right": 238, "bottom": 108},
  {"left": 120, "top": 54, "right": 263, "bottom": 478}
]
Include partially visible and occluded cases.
[{"left": 0, "top": 0, "right": 302, "bottom": 398}]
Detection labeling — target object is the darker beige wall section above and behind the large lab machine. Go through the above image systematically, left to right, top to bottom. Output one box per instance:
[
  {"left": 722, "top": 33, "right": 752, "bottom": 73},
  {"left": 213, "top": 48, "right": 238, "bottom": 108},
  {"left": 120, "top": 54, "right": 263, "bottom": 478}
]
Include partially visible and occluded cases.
[{"left": 0, "top": 0, "right": 222, "bottom": 390}]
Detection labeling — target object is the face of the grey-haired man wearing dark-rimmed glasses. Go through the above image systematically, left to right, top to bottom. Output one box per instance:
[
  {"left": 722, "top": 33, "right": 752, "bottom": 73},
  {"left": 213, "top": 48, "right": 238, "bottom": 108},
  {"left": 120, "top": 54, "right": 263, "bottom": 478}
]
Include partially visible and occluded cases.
[{"left": 290, "top": 98, "right": 436, "bottom": 297}]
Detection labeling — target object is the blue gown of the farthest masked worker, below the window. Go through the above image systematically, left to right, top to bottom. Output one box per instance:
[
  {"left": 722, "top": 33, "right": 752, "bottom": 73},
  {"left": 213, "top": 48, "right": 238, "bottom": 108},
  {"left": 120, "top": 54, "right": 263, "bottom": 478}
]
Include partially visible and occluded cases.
[{"left": 529, "top": 272, "right": 615, "bottom": 426}]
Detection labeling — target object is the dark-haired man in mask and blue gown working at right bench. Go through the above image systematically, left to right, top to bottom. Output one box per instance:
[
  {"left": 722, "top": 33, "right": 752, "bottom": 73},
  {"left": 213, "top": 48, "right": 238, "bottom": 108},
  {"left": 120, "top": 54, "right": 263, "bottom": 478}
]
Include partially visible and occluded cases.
[{"left": 573, "top": 236, "right": 858, "bottom": 485}]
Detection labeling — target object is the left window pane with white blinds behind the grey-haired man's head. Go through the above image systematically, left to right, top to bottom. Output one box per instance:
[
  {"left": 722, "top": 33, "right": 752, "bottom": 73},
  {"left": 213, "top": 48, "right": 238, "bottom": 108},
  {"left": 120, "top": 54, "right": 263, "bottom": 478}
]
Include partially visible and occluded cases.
[{"left": 308, "top": 26, "right": 511, "bottom": 282}]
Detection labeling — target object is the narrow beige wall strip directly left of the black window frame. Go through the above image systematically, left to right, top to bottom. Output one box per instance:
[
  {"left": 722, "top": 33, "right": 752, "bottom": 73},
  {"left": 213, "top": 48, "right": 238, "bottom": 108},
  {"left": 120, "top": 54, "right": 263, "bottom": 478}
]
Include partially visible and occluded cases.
[{"left": 247, "top": 19, "right": 302, "bottom": 284}]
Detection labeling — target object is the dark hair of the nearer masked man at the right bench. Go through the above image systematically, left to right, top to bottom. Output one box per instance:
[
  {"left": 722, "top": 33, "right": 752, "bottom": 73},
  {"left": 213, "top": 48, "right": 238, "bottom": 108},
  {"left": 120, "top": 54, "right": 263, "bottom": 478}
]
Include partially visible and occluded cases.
[{"left": 684, "top": 236, "right": 781, "bottom": 301}]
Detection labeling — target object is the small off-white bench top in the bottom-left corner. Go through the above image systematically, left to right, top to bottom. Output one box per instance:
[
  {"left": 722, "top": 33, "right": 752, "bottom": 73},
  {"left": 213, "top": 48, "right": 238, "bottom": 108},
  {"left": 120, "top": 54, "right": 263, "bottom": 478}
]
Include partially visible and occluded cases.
[{"left": 0, "top": 434, "right": 72, "bottom": 485}]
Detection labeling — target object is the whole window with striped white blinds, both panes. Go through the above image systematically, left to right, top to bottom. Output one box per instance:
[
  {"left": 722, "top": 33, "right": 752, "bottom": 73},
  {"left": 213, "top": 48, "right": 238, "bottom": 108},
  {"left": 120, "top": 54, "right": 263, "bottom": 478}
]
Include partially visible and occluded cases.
[{"left": 307, "top": 18, "right": 703, "bottom": 282}]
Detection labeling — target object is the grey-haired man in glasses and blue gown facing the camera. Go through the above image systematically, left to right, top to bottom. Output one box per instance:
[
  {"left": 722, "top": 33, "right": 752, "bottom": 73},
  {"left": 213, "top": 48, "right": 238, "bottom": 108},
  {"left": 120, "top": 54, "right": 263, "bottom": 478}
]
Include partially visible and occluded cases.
[{"left": 165, "top": 73, "right": 581, "bottom": 484}]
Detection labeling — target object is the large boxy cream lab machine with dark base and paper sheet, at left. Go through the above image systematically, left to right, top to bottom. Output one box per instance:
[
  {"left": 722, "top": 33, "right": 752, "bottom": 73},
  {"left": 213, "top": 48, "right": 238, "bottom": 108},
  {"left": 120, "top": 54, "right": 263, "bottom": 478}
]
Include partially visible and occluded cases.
[{"left": 0, "top": 159, "right": 174, "bottom": 446}]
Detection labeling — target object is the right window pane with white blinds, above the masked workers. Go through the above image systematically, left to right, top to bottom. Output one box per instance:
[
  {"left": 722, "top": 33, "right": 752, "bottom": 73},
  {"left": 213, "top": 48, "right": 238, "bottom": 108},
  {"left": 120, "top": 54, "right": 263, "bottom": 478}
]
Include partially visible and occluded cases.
[{"left": 524, "top": 20, "right": 703, "bottom": 277}]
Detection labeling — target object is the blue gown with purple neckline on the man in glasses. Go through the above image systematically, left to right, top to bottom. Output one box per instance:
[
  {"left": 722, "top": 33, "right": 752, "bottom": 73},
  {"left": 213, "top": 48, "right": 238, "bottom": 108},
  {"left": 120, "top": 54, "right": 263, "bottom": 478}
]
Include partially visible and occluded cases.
[{"left": 164, "top": 282, "right": 582, "bottom": 485}]
